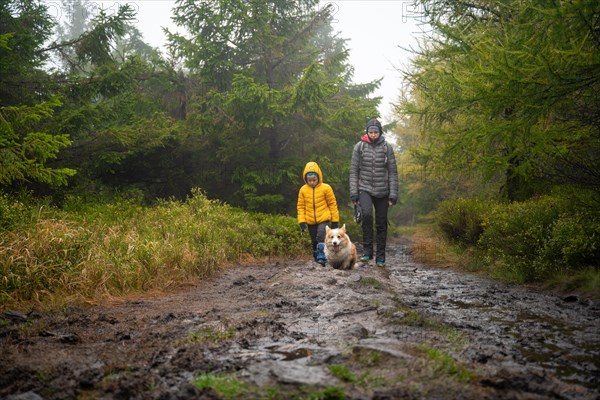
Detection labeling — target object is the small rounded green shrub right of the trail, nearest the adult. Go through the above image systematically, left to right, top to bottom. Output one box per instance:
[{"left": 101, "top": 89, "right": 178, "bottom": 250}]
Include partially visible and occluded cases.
[{"left": 435, "top": 199, "right": 492, "bottom": 247}]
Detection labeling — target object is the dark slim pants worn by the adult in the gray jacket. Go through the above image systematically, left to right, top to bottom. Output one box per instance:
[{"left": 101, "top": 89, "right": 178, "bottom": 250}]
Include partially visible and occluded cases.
[{"left": 358, "top": 192, "right": 389, "bottom": 262}]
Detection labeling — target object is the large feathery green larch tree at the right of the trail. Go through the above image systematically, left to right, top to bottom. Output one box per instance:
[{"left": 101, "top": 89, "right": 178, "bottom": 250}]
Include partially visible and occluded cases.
[{"left": 399, "top": 0, "right": 600, "bottom": 200}]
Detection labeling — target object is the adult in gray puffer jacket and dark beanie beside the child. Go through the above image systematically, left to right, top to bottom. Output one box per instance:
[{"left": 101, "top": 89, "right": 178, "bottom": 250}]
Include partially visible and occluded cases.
[{"left": 350, "top": 118, "right": 398, "bottom": 267}]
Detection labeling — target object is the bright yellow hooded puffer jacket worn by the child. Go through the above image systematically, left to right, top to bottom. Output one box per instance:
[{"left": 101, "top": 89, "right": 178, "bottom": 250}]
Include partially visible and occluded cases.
[{"left": 298, "top": 161, "right": 340, "bottom": 225}]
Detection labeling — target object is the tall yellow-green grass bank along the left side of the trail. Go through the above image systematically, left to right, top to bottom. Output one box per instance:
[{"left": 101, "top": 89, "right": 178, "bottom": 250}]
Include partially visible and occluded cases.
[{"left": 0, "top": 191, "right": 309, "bottom": 309}]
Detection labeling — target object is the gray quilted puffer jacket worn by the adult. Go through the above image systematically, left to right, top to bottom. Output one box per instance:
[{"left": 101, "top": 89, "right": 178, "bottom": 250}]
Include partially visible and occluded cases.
[{"left": 350, "top": 135, "right": 398, "bottom": 202}]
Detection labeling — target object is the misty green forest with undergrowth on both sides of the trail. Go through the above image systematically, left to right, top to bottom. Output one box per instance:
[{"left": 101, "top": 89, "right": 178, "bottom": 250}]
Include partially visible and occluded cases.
[{"left": 0, "top": 0, "right": 600, "bottom": 304}]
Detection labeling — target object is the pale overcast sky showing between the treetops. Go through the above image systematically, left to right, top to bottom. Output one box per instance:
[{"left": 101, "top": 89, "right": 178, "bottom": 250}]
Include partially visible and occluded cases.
[{"left": 45, "top": 0, "right": 424, "bottom": 123}]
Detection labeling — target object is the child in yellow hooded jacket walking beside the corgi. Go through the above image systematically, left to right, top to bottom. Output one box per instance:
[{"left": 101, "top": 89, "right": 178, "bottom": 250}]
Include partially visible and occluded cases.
[{"left": 298, "top": 161, "right": 340, "bottom": 266}]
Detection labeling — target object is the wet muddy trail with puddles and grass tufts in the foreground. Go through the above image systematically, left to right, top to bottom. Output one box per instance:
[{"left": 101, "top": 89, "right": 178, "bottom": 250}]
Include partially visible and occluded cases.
[{"left": 0, "top": 241, "right": 600, "bottom": 400}]
